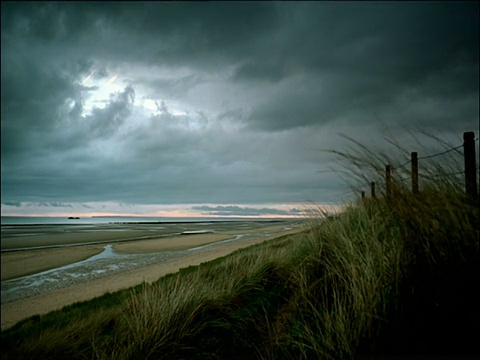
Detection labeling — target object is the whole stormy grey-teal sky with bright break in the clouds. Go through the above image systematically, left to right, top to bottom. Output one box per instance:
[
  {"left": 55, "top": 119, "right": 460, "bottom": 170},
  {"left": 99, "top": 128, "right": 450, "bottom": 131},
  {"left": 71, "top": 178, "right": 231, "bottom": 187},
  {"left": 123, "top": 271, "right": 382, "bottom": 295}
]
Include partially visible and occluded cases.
[{"left": 1, "top": 1, "right": 479, "bottom": 216}]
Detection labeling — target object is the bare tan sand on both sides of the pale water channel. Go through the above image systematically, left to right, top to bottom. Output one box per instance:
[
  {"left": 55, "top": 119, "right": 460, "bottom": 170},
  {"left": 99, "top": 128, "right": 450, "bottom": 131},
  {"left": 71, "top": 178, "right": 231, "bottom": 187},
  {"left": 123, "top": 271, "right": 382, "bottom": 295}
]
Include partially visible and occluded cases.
[{"left": 1, "top": 219, "right": 304, "bottom": 330}]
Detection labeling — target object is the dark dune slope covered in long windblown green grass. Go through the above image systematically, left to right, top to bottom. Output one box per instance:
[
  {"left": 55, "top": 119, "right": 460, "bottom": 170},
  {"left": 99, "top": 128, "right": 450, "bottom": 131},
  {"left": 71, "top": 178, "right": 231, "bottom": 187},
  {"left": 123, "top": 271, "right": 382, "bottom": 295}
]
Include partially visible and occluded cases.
[{"left": 2, "top": 137, "right": 480, "bottom": 359}]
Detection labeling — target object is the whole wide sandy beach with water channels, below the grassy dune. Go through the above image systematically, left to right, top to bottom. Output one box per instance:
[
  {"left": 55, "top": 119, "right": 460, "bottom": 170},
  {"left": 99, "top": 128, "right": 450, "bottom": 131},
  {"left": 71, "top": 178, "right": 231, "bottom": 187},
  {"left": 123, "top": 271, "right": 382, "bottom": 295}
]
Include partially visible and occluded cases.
[{"left": 1, "top": 220, "right": 304, "bottom": 330}]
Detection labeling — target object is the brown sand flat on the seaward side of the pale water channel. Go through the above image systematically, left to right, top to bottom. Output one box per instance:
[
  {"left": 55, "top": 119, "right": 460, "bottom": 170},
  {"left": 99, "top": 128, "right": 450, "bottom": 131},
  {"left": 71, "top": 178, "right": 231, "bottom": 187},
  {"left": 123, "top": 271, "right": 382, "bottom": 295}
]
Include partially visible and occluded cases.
[{"left": 1, "top": 223, "right": 300, "bottom": 280}]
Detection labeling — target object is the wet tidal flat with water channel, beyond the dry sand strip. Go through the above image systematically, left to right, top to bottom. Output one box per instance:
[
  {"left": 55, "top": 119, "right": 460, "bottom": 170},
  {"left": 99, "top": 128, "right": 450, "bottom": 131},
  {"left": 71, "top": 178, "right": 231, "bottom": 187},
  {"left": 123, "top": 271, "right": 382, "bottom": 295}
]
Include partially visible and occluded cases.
[{"left": 2, "top": 221, "right": 302, "bottom": 303}]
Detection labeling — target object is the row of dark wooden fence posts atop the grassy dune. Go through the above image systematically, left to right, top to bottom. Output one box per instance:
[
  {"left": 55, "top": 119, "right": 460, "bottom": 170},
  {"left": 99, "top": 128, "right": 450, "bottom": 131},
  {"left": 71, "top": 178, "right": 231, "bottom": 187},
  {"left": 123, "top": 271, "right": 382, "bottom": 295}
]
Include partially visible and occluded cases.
[{"left": 362, "top": 131, "right": 478, "bottom": 200}]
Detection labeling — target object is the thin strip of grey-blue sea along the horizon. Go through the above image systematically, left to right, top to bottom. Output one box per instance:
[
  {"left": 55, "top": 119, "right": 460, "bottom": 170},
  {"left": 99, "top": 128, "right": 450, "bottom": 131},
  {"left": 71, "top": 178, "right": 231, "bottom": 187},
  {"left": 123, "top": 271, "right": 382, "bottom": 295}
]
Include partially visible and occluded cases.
[{"left": 1, "top": 216, "right": 284, "bottom": 225}]
